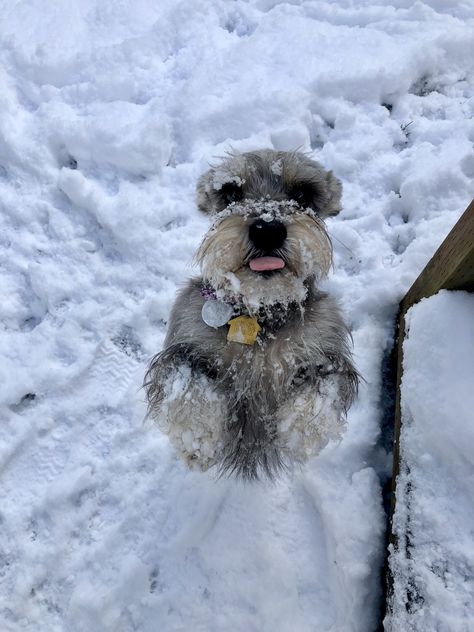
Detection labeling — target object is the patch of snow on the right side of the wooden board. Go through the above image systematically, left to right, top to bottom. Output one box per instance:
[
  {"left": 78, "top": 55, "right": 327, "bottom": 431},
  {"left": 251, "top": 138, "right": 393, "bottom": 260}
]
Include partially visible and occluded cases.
[{"left": 387, "top": 291, "right": 474, "bottom": 632}]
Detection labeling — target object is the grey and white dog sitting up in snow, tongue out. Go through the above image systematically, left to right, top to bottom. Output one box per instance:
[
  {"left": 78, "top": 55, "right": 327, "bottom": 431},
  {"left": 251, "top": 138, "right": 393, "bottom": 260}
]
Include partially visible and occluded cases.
[{"left": 145, "top": 150, "right": 358, "bottom": 479}]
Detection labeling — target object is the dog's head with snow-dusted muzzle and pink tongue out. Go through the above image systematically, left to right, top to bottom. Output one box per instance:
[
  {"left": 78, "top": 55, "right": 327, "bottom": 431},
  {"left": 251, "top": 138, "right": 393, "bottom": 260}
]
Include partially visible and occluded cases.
[{"left": 197, "top": 150, "right": 341, "bottom": 310}]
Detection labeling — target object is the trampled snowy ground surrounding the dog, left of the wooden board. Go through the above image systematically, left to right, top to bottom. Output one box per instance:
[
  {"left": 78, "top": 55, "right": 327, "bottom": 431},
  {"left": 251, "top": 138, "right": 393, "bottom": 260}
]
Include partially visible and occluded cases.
[{"left": 0, "top": 0, "right": 474, "bottom": 632}]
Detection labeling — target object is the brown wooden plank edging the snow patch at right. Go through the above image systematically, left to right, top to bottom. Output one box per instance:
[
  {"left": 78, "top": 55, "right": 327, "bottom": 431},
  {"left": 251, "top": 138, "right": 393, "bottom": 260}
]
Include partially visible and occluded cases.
[{"left": 387, "top": 200, "right": 474, "bottom": 605}]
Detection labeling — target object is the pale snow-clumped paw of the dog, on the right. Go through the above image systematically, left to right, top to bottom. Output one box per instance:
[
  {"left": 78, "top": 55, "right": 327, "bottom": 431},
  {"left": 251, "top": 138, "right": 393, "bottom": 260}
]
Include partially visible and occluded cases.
[{"left": 277, "top": 374, "right": 346, "bottom": 462}]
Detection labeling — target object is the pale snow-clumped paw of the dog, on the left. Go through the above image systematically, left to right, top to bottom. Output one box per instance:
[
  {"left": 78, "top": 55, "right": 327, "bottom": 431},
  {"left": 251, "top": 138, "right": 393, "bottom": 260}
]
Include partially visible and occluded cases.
[{"left": 153, "top": 365, "right": 227, "bottom": 471}]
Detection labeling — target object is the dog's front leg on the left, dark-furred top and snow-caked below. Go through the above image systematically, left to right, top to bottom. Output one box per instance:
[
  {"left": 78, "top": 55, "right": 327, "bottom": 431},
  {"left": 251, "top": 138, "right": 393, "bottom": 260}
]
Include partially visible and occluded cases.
[{"left": 145, "top": 344, "right": 227, "bottom": 470}]
